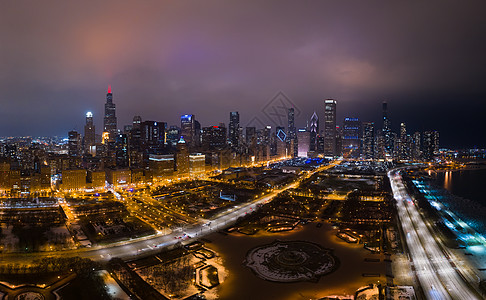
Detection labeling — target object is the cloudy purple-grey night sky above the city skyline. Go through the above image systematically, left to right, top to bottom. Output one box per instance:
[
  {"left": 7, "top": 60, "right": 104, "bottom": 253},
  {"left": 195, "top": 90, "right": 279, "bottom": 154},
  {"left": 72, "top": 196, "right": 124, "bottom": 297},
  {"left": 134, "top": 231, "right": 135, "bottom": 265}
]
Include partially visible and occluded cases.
[{"left": 0, "top": 0, "right": 486, "bottom": 147}]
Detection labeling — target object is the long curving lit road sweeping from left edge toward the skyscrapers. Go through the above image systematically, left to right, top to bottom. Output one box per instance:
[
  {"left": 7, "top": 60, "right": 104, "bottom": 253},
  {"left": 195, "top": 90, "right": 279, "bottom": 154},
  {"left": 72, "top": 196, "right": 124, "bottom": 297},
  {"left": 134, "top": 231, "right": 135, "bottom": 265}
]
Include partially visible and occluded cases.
[{"left": 0, "top": 163, "right": 335, "bottom": 264}]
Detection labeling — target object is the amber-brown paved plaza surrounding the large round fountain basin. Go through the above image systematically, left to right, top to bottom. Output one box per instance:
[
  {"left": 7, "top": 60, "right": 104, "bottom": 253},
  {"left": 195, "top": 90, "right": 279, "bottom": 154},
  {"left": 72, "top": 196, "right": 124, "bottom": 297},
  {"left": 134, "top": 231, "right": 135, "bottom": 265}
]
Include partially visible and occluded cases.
[{"left": 208, "top": 223, "right": 386, "bottom": 300}]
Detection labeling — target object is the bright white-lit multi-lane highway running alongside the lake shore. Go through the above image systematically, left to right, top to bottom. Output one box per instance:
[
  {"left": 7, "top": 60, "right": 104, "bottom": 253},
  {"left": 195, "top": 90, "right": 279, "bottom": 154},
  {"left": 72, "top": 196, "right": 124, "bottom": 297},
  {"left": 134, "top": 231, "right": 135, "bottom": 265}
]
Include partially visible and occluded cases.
[{"left": 388, "top": 170, "right": 480, "bottom": 300}]
